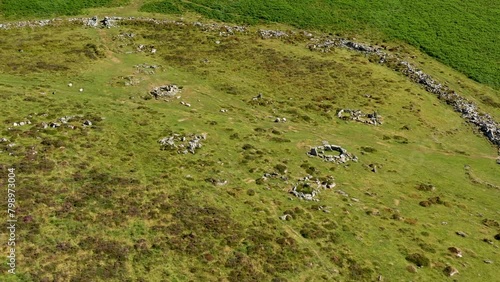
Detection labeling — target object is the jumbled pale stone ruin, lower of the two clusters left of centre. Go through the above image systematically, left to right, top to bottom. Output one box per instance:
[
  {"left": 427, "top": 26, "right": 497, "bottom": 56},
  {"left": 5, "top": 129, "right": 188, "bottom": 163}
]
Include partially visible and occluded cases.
[{"left": 158, "top": 133, "right": 207, "bottom": 154}]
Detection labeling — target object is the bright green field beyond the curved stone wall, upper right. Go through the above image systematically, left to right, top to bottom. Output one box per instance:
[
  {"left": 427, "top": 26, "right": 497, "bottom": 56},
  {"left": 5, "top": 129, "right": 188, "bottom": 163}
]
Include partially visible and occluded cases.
[{"left": 137, "top": 0, "right": 500, "bottom": 89}]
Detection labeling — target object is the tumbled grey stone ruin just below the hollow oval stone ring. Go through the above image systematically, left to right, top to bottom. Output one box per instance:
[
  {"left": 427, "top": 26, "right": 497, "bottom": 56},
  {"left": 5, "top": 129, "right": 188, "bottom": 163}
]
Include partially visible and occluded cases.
[{"left": 289, "top": 175, "right": 336, "bottom": 202}]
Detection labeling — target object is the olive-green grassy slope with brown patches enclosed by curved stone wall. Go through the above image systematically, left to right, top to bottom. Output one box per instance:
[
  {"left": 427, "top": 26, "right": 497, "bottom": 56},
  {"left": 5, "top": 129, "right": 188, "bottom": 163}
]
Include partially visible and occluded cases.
[{"left": 0, "top": 18, "right": 500, "bottom": 281}]
